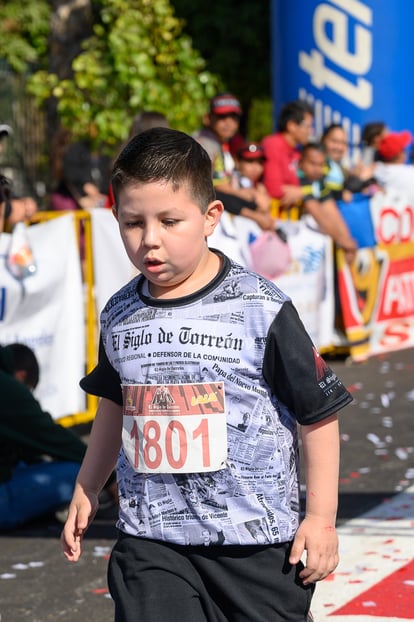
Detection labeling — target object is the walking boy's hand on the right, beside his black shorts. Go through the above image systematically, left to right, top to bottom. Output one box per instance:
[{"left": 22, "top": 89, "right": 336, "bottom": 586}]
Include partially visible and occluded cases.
[{"left": 289, "top": 516, "right": 339, "bottom": 585}]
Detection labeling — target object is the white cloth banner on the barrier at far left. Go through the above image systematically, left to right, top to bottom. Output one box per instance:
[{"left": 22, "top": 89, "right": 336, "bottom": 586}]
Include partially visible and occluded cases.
[{"left": 0, "top": 215, "right": 85, "bottom": 418}]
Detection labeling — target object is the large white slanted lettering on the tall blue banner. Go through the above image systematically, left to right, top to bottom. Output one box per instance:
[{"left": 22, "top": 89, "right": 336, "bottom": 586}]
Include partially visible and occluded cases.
[{"left": 298, "top": 0, "right": 373, "bottom": 153}]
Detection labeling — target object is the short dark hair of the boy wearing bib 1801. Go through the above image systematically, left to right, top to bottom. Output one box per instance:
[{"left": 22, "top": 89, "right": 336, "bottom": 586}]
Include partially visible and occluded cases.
[{"left": 112, "top": 127, "right": 215, "bottom": 213}]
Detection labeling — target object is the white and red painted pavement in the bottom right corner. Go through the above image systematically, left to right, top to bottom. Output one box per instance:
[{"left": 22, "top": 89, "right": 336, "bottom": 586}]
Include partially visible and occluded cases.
[{"left": 312, "top": 486, "right": 414, "bottom": 622}]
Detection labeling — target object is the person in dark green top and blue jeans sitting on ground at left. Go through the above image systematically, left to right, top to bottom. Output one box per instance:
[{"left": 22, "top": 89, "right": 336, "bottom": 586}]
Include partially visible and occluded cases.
[{"left": 0, "top": 343, "right": 116, "bottom": 529}]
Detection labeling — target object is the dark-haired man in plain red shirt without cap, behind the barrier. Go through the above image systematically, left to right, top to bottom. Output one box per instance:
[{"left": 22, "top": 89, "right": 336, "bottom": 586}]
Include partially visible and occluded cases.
[{"left": 262, "top": 101, "right": 313, "bottom": 208}]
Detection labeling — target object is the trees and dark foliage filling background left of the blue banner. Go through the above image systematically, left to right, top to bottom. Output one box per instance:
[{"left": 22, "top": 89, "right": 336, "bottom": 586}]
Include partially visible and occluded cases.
[{"left": 0, "top": 0, "right": 270, "bottom": 145}]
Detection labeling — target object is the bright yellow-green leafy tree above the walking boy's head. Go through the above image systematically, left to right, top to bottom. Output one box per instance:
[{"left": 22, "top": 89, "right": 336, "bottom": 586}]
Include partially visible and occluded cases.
[{"left": 29, "top": 0, "right": 219, "bottom": 145}]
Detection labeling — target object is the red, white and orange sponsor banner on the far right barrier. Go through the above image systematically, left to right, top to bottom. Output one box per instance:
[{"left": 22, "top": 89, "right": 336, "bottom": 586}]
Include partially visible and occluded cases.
[{"left": 338, "top": 188, "right": 414, "bottom": 360}]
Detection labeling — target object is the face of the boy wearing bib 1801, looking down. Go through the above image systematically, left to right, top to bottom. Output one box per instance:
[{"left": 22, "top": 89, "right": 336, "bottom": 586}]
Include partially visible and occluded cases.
[{"left": 114, "top": 182, "right": 223, "bottom": 298}]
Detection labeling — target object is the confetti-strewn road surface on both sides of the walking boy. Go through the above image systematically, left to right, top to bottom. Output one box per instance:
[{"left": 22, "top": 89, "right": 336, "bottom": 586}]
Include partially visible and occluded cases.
[{"left": 0, "top": 349, "right": 414, "bottom": 622}]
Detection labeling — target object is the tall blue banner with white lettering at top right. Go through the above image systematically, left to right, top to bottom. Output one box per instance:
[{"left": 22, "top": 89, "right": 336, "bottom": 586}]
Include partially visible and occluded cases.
[{"left": 271, "top": 0, "right": 414, "bottom": 150}]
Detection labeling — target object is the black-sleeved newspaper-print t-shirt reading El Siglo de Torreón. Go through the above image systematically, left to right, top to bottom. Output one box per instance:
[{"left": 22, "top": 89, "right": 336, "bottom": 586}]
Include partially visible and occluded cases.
[{"left": 94, "top": 257, "right": 351, "bottom": 546}]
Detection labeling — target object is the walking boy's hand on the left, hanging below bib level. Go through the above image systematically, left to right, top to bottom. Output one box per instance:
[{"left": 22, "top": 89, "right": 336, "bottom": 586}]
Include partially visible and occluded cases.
[{"left": 60, "top": 484, "right": 99, "bottom": 562}]
